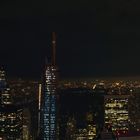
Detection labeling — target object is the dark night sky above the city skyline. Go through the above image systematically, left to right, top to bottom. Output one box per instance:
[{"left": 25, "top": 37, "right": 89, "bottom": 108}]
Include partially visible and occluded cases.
[{"left": 0, "top": 0, "right": 140, "bottom": 78}]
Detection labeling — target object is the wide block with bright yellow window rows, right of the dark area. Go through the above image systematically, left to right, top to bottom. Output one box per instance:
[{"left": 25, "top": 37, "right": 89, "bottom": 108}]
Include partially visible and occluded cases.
[{"left": 105, "top": 95, "right": 129, "bottom": 133}]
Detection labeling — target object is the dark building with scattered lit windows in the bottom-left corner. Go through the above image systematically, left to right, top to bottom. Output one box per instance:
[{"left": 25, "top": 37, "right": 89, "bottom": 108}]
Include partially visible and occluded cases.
[{"left": 0, "top": 106, "right": 23, "bottom": 140}]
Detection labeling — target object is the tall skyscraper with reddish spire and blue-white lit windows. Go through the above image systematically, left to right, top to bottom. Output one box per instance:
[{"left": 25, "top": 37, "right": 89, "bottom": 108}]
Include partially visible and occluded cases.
[{"left": 41, "top": 32, "right": 57, "bottom": 140}]
